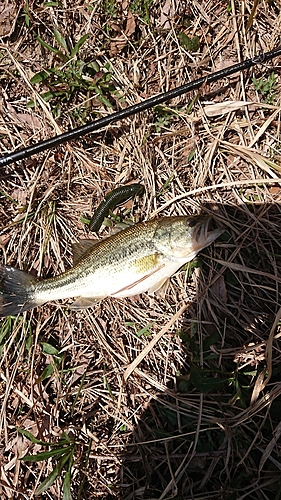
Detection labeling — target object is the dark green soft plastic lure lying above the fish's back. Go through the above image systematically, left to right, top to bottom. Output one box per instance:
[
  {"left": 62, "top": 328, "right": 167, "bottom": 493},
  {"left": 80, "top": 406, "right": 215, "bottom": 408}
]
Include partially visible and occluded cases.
[{"left": 89, "top": 184, "right": 144, "bottom": 232}]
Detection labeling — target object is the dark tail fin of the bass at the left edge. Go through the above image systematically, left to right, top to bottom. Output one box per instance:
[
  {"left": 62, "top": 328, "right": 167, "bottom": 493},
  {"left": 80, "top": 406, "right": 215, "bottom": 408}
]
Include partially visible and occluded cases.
[{"left": 0, "top": 266, "right": 39, "bottom": 318}]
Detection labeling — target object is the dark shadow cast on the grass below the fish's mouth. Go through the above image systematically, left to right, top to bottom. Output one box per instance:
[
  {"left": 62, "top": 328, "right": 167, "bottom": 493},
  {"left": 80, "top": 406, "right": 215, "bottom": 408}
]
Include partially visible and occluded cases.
[{"left": 117, "top": 203, "right": 281, "bottom": 500}]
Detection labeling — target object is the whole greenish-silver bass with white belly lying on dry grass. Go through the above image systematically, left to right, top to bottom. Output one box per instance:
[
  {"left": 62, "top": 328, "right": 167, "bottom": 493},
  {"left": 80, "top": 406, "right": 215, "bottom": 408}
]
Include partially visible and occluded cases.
[{"left": 0, "top": 215, "right": 224, "bottom": 317}]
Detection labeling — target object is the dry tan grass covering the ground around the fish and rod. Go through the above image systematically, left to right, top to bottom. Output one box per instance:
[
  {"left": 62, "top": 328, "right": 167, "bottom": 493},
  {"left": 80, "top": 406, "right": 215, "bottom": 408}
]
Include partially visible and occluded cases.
[{"left": 0, "top": 0, "right": 281, "bottom": 500}]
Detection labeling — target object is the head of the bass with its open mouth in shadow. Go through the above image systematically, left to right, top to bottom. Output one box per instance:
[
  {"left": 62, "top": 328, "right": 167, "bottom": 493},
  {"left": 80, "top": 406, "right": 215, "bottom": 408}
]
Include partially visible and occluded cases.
[{"left": 155, "top": 215, "right": 225, "bottom": 262}]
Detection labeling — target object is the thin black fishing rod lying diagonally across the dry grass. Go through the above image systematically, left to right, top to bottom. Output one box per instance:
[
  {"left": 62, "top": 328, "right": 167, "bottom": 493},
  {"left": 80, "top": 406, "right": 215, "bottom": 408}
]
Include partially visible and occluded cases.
[{"left": 0, "top": 47, "right": 281, "bottom": 167}]
